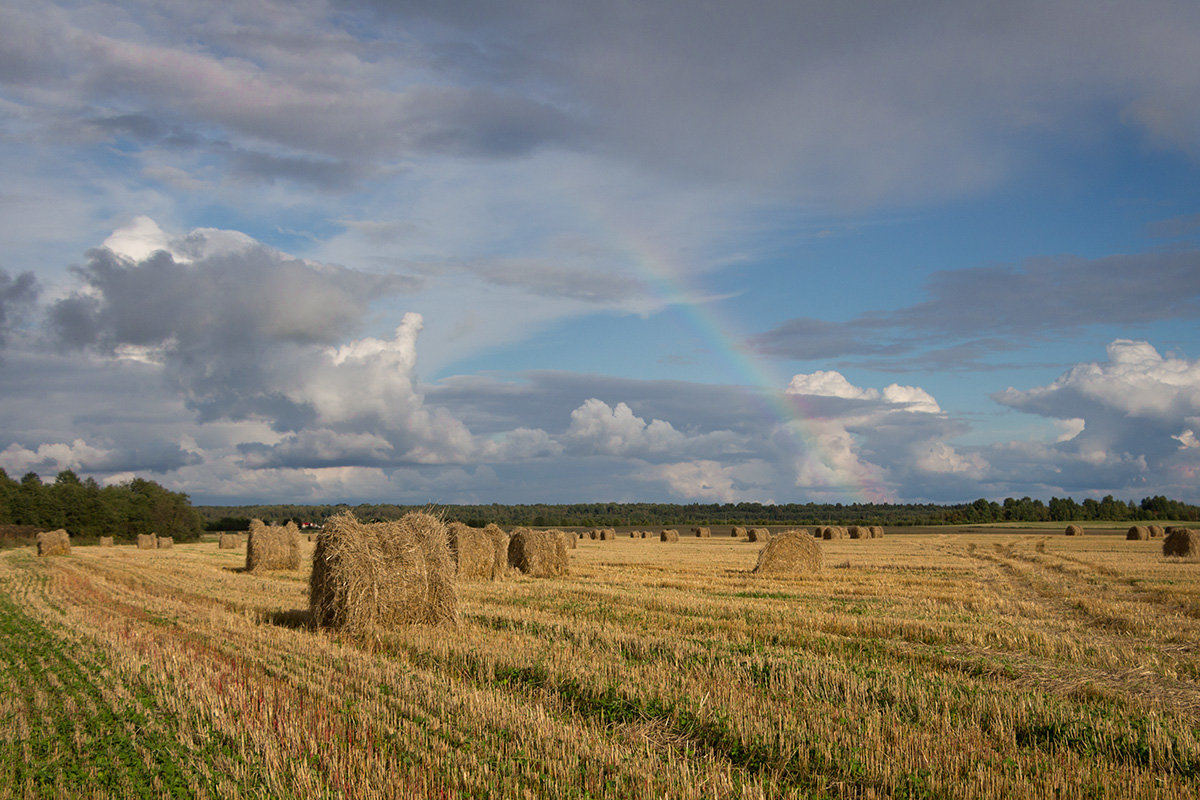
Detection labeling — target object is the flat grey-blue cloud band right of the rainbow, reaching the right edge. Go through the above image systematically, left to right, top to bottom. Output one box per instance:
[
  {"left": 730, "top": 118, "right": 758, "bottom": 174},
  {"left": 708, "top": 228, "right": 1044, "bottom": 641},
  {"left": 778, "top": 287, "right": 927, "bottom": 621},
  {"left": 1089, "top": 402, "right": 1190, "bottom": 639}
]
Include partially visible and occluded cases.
[{"left": 751, "top": 249, "right": 1200, "bottom": 368}]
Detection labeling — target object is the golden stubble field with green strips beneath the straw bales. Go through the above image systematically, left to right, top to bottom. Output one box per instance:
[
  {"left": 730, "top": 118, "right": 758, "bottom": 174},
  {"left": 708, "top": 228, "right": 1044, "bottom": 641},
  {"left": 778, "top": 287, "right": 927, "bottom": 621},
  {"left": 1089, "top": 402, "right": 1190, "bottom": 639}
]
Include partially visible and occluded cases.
[{"left": 0, "top": 529, "right": 1200, "bottom": 799}]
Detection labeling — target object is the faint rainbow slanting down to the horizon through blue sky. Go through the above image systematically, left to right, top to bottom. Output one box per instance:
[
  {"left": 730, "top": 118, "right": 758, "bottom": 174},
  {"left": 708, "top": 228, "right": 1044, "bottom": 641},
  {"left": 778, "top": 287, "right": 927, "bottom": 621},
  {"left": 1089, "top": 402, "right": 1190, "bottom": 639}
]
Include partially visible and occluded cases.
[{"left": 604, "top": 219, "right": 888, "bottom": 503}]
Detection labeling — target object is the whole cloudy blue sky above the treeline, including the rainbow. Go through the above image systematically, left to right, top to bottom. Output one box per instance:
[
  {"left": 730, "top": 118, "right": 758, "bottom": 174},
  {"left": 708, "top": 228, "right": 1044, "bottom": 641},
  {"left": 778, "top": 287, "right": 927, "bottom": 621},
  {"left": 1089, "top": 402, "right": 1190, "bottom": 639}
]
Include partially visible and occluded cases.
[{"left": 0, "top": 0, "right": 1200, "bottom": 504}]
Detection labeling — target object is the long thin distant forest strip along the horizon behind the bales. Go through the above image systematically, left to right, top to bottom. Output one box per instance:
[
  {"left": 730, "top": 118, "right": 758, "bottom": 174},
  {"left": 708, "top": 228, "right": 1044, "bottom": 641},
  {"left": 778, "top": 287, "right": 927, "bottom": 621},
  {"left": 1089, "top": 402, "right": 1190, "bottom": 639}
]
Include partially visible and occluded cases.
[{"left": 197, "top": 495, "right": 1200, "bottom": 530}]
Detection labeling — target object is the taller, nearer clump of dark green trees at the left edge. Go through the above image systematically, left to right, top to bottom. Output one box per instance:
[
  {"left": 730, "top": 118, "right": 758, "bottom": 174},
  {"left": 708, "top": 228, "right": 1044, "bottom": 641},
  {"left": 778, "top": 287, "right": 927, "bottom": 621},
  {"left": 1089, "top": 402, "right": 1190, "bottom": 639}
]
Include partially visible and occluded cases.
[{"left": 0, "top": 469, "right": 204, "bottom": 541}]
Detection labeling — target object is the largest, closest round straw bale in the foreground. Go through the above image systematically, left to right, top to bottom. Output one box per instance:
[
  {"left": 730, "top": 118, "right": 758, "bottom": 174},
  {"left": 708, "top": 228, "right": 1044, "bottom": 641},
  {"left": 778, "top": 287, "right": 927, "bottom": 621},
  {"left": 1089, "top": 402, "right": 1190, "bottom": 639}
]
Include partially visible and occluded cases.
[{"left": 308, "top": 512, "right": 458, "bottom": 631}]
